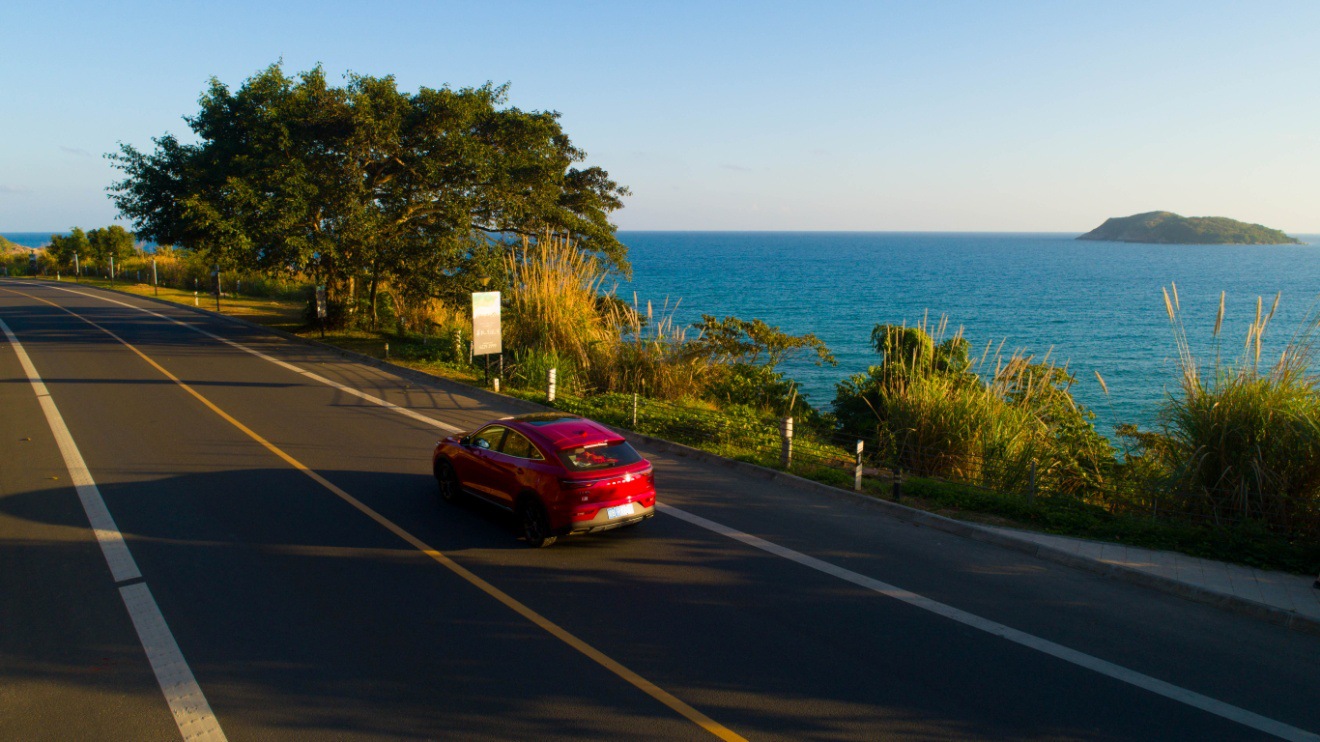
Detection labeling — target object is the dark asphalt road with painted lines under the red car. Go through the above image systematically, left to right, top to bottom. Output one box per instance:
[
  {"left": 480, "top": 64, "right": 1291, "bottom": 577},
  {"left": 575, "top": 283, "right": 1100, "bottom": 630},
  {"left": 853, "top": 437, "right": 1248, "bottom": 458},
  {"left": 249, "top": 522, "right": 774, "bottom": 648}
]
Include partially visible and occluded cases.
[{"left": 0, "top": 280, "right": 1320, "bottom": 741}]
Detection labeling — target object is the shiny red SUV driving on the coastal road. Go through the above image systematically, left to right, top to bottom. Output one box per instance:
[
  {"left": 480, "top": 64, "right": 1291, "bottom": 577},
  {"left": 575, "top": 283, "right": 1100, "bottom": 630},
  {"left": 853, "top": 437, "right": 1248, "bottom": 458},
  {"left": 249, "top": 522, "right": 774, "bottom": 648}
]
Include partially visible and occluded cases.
[{"left": 432, "top": 412, "right": 656, "bottom": 548}]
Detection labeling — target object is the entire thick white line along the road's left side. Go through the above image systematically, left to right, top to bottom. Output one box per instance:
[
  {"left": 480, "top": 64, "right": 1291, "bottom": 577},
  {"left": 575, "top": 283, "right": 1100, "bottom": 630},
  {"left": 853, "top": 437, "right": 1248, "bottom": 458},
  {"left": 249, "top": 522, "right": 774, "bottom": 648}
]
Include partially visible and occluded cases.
[{"left": 0, "top": 311, "right": 224, "bottom": 742}]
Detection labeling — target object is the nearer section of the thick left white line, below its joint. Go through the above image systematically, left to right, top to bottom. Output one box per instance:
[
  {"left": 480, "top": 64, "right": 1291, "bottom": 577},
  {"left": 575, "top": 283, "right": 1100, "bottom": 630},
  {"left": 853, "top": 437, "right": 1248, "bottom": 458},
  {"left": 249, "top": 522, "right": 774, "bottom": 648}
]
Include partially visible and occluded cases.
[{"left": 119, "top": 582, "right": 226, "bottom": 742}]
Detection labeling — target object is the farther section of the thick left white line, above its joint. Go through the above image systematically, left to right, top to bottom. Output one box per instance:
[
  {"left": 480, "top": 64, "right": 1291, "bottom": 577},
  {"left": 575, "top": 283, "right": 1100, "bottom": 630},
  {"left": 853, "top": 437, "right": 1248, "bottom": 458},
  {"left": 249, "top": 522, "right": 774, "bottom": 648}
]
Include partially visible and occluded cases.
[{"left": 0, "top": 314, "right": 143, "bottom": 582}]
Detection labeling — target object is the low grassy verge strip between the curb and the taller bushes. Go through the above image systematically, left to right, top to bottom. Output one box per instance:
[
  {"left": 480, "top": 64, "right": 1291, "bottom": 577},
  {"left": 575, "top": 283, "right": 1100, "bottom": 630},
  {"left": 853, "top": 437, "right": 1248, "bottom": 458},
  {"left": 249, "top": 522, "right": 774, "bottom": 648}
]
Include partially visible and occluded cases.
[{"left": 36, "top": 279, "right": 1320, "bottom": 574}]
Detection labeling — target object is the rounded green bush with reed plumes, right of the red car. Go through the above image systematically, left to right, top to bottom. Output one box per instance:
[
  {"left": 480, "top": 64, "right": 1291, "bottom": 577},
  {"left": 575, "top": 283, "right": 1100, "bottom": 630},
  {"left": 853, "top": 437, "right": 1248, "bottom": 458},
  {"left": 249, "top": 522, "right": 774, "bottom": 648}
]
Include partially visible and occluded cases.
[{"left": 834, "top": 322, "right": 1114, "bottom": 496}]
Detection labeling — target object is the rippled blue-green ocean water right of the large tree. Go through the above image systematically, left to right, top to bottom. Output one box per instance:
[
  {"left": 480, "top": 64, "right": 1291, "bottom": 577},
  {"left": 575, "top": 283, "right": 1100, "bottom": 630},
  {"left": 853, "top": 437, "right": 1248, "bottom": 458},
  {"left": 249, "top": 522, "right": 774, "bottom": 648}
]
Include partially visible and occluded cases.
[{"left": 618, "top": 232, "right": 1320, "bottom": 434}]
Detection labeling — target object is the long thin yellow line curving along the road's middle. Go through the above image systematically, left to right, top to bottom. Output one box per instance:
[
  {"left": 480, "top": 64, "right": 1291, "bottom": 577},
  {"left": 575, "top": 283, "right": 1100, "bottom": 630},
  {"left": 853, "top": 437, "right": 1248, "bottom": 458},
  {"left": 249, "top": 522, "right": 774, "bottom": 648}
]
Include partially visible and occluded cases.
[{"left": 10, "top": 289, "right": 746, "bottom": 742}]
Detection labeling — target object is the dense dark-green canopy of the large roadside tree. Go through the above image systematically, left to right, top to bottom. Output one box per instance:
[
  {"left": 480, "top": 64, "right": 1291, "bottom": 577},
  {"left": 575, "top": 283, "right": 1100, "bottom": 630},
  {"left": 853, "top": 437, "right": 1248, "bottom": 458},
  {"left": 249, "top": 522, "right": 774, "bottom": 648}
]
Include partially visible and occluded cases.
[{"left": 110, "top": 63, "right": 630, "bottom": 324}]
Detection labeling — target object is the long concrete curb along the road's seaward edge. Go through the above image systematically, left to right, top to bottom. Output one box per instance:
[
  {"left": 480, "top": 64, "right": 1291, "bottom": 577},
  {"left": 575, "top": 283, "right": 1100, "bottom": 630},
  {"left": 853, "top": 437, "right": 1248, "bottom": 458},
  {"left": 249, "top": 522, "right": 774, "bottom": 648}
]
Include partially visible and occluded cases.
[{"left": 56, "top": 281, "right": 1320, "bottom": 636}]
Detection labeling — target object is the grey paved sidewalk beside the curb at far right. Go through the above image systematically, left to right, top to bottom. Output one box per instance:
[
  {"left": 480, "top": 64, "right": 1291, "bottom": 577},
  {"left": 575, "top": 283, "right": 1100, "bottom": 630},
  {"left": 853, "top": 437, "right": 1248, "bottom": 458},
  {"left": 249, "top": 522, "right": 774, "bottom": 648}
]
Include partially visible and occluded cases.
[{"left": 982, "top": 525, "right": 1320, "bottom": 624}]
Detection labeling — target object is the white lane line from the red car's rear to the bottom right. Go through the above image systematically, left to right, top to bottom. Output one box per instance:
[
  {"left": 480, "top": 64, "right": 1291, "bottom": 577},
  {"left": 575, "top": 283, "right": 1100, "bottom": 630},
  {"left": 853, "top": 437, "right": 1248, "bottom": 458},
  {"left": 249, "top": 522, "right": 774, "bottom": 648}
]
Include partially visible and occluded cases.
[{"left": 656, "top": 503, "right": 1320, "bottom": 741}]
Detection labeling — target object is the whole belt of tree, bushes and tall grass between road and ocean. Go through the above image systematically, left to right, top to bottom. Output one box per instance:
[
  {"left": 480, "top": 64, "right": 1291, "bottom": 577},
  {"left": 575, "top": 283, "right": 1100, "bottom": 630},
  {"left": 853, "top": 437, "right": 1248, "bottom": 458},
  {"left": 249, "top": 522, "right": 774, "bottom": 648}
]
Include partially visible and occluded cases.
[{"left": 7, "top": 66, "right": 1320, "bottom": 572}]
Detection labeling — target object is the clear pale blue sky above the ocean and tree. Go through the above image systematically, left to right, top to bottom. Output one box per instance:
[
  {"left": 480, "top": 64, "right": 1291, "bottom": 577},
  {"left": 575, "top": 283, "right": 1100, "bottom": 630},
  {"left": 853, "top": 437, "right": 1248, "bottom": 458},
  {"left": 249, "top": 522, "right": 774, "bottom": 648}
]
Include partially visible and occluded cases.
[{"left": 0, "top": 1, "right": 1320, "bottom": 234}]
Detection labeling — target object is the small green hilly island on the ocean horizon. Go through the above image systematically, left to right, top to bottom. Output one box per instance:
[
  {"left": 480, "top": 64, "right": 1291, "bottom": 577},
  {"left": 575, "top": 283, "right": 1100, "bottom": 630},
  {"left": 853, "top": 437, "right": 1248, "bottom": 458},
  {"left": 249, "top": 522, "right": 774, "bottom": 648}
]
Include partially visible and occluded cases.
[{"left": 1077, "top": 211, "right": 1302, "bottom": 244}]
